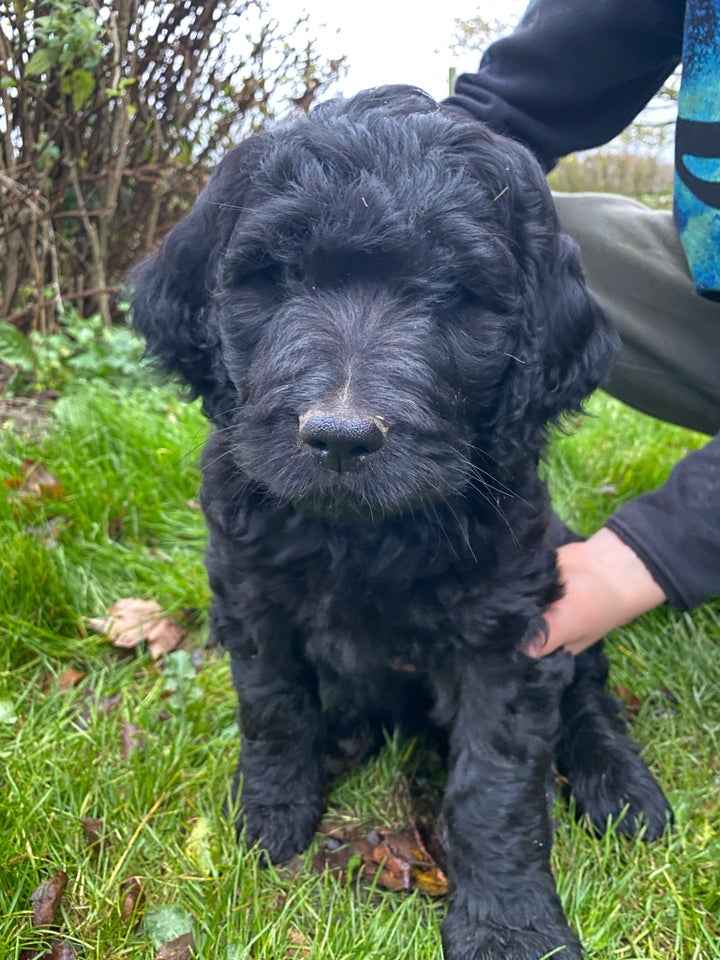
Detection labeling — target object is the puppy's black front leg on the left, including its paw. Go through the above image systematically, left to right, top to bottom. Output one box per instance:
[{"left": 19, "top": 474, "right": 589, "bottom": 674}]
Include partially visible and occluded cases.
[{"left": 221, "top": 634, "right": 323, "bottom": 863}]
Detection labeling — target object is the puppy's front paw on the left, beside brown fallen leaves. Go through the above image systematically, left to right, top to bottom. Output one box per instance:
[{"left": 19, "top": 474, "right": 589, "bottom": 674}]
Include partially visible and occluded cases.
[{"left": 237, "top": 803, "right": 322, "bottom": 864}]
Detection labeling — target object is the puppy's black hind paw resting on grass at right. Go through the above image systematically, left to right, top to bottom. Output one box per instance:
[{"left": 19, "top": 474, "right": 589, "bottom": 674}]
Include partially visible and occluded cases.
[{"left": 567, "top": 746, "right": 673, "bottom": 840}]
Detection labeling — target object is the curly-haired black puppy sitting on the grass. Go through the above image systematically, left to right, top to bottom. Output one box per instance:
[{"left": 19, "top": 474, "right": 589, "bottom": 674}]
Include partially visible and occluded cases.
[{"left": 133, "top": 87, "right": 669, "bottom": 960}]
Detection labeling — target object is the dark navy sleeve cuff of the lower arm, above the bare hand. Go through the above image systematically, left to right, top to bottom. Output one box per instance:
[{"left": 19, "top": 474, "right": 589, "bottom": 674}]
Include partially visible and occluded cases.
[{"left": 606, "top": 434, "right": 720, "bottom": 610}]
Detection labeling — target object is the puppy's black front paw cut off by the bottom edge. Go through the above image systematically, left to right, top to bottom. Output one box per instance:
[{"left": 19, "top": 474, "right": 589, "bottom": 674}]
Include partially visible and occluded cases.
[{"left": 442, "top": 914, "right": 583, "bottom": 960}]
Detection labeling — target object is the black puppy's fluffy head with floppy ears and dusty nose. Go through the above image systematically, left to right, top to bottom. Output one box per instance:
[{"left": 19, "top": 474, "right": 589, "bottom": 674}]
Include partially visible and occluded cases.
[{"left": 132, "top": 87, "right": 614, "bottom": 517}]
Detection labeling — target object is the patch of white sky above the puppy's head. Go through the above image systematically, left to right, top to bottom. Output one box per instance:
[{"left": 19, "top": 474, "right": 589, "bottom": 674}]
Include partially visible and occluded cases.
[{"left": 268, "top": 0, "right": 527, "bottom": 99}]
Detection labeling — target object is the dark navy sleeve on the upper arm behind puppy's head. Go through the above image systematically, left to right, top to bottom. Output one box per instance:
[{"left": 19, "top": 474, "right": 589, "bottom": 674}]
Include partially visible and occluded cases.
[{"left": 445, "top": 0, "right": 685, "bottom": 170}]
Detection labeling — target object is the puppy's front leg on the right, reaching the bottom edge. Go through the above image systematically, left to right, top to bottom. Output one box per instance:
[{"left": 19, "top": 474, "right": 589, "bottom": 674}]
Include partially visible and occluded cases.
[{"left": 438, "top": 651, "right": 582, "bottom": 960}]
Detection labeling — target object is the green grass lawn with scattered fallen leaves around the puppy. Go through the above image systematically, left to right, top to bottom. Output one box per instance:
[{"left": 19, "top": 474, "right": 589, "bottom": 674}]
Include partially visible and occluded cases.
[{"left": 0, "top": 387, "right": 720, "bottom": 960}]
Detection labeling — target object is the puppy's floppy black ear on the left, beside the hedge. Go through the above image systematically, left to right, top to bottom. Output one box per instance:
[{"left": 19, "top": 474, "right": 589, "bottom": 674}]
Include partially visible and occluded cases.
[{"left": 129, "top": 137, "right": 263, "bottom": 415}]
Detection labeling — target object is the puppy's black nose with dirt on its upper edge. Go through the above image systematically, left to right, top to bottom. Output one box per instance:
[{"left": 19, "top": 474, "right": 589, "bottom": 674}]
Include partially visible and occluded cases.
[{"left": 299, "top": 410, "right": 387, "bottom": 473}]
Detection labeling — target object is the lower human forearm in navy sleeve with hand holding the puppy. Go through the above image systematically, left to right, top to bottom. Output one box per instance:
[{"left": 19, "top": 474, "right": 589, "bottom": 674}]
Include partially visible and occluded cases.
[{"left": 527, "top": 435, "right": 720, "bottom": 656}]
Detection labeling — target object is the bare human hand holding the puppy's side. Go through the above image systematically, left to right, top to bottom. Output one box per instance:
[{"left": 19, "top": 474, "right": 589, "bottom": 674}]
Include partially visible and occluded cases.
[{"left": 524, "top": 527, "right": 666, "bottom": 657}]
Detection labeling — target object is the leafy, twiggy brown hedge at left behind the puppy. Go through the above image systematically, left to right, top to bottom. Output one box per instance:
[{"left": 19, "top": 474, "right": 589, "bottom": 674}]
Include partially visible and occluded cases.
[{"left": 0, "top": 0, "right": 341, "bottom": 331}]
